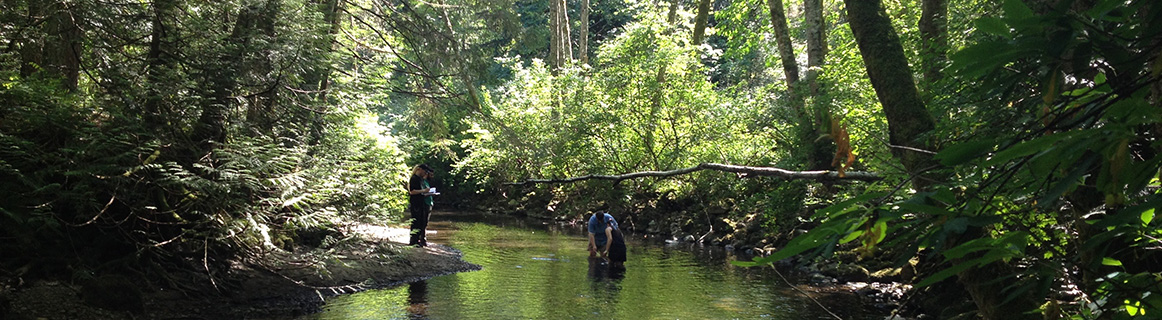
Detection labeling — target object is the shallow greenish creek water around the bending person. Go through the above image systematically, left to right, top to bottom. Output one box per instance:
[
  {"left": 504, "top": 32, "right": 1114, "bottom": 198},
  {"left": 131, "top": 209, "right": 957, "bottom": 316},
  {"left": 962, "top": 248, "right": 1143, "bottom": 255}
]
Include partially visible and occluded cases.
[{"left": 304, "top": 213, "right": 883, "bottom": 319}]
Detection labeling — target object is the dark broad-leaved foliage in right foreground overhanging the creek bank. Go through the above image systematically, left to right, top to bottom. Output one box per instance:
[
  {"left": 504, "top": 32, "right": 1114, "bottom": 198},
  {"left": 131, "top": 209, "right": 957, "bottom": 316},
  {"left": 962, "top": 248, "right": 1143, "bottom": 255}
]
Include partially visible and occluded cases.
[{"left": 746, "top": 0, "right": 1162, "bottom": 319}]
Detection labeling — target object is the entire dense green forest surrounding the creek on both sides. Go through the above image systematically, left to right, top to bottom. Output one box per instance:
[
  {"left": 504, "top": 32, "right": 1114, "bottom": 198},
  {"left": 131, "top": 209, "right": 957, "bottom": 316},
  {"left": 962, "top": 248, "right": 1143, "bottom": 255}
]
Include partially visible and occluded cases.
[{"left": 0, "top": 0, "right": 1162, "bottom": 319}]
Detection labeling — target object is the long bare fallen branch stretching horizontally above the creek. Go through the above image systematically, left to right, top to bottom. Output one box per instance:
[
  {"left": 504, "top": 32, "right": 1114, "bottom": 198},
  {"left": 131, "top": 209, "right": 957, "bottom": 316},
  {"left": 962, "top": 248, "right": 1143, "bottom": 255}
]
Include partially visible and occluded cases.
[{"left": 504, "top": 163, "right": 883, "bottom": 185}]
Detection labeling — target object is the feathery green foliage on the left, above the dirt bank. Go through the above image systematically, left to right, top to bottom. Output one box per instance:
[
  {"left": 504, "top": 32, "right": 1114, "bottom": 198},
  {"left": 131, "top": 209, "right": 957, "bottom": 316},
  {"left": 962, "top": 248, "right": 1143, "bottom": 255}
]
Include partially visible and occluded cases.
[{"left": 0, "top": 0, "right": 407, "bottom": 287}]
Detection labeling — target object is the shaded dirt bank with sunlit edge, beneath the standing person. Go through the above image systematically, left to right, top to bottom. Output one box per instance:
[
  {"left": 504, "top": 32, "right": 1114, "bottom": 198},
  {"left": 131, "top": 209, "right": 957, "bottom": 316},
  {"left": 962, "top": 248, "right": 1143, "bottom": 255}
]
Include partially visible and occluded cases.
[{"left": 0, "top": 225, "right": 480, "bottom": 320}]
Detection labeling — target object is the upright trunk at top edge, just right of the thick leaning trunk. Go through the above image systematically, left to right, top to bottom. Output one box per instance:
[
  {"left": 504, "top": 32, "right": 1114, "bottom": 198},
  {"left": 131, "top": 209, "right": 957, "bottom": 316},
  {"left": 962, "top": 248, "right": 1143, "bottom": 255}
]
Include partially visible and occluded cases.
[{"left": 918, "top": 0, "right": 948, "bottom": 89}]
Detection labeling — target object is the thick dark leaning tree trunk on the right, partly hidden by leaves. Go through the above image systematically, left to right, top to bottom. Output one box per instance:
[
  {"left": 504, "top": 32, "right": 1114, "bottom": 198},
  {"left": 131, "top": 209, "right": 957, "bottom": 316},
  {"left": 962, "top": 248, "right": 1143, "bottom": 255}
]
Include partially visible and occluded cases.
[{"left": 844, "top": 0, "right": 1039, "bottom": 319}]
